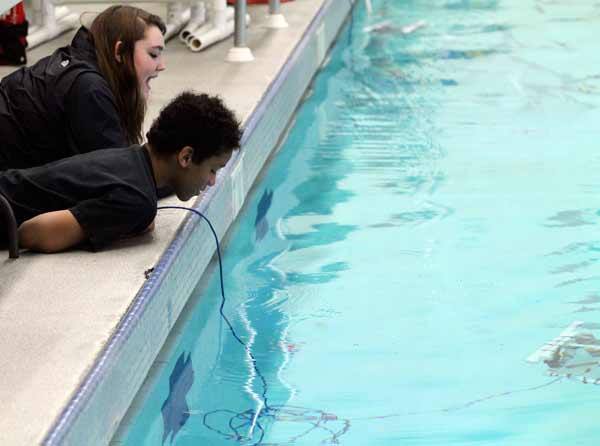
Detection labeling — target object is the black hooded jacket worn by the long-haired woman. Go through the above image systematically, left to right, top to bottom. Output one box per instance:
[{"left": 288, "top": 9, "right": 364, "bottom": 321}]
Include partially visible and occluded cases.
[{"left": 0, "top": 28, "right": 129, "bottom": 170}]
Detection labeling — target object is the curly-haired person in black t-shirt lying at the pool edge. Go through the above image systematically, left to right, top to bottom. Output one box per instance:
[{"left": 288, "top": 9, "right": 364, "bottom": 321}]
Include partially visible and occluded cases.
[{"left": 0, "top": 92, "right": 241, "bottom": 252}]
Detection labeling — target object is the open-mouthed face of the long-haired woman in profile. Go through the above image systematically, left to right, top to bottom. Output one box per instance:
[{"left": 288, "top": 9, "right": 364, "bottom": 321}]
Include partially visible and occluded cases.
[{"left": 133, "top": 25, "right": 165, "bottom": 100}]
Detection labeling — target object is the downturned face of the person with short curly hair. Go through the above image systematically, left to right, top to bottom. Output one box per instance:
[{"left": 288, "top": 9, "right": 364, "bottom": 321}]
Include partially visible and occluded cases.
[{"left": 175, "top": 149, "right": 232, "bottom": 201}]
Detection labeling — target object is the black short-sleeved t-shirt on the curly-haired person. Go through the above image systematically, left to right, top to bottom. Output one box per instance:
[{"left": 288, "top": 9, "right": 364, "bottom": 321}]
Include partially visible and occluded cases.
[{"left": 0, "top": 146, "right": 157, "bottom": 249}]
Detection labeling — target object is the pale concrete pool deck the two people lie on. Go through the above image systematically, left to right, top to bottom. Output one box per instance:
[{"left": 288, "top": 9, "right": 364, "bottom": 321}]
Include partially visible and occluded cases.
[{"left": 0, "top": 0, "right": 348, "bottom": 446}]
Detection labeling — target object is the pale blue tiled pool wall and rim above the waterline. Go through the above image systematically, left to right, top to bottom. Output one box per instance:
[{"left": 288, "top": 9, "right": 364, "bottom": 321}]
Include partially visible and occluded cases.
[{"left": 43, "top": 0, "right": 357, "bottom": 446}]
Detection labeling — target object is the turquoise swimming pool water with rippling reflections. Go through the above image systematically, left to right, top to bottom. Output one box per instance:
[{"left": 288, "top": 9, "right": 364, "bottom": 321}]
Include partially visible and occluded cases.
[{"left": 116, "top": 0, "right": 600, "bottom": 446}]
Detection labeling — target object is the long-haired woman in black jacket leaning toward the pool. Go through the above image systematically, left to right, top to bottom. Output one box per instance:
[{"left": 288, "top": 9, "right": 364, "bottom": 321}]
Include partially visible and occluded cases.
[{"left": 0, "top": 5, "right": 166, "bottom": 171}]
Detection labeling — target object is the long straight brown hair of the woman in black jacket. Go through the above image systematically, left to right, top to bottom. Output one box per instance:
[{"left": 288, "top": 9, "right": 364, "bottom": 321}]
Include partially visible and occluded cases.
[{"left": 90, "top": 5, "right": 166, "bottom": 144}]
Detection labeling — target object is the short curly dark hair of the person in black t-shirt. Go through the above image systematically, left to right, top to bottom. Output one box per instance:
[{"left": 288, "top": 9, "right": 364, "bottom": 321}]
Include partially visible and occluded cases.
[{"left": 146, "top": 91, "right": 242, "bottom": 164}]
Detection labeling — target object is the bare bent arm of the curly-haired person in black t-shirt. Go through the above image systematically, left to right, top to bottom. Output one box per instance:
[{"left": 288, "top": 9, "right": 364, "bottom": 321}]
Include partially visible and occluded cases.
[{"left": 19, "top": 210, "right": 86, "bottom": 253}]
